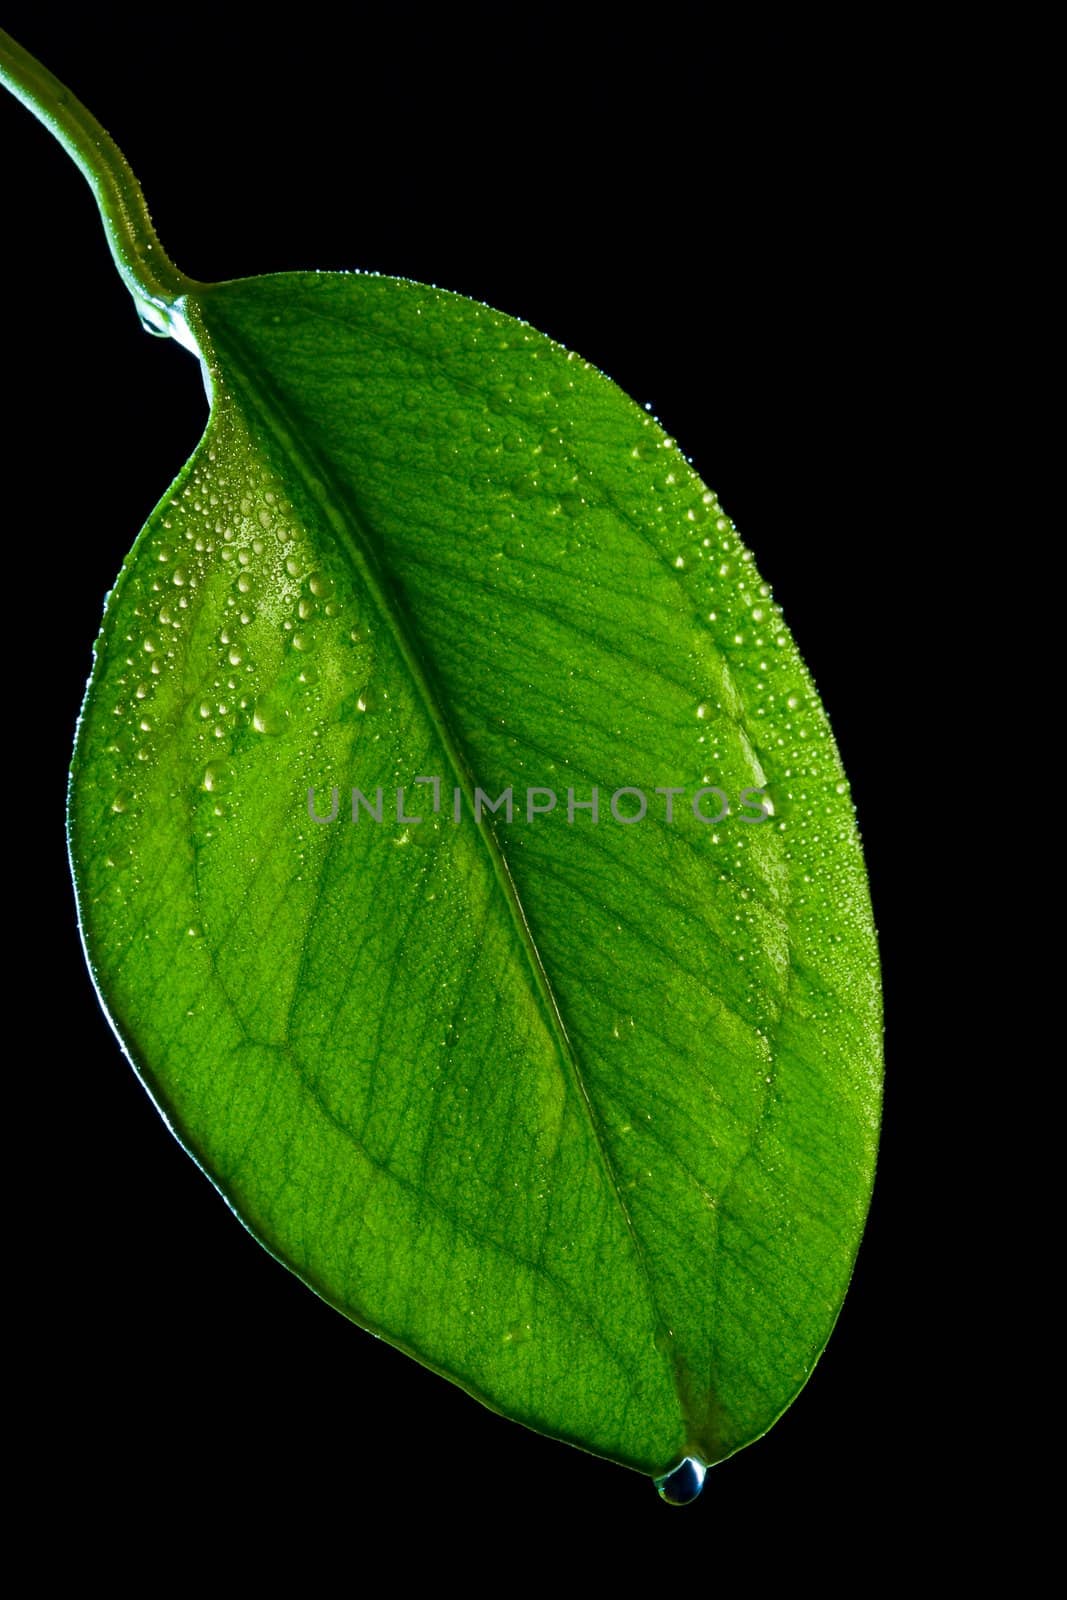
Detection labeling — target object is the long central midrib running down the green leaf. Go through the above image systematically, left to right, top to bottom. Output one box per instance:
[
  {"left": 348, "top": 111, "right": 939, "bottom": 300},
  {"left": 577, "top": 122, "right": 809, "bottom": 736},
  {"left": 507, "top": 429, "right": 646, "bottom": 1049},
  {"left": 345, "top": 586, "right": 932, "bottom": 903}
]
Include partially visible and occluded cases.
[{"left": 190, "top": 296, "right": 689, "bottom": 1416}]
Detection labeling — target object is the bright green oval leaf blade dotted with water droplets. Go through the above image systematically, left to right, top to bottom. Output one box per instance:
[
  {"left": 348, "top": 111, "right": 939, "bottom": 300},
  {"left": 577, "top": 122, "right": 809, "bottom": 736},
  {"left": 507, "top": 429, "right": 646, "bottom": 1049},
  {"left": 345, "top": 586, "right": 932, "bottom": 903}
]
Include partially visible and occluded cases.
[{"left": 70, "top": 275, "right": 880, "bottom": 1472}]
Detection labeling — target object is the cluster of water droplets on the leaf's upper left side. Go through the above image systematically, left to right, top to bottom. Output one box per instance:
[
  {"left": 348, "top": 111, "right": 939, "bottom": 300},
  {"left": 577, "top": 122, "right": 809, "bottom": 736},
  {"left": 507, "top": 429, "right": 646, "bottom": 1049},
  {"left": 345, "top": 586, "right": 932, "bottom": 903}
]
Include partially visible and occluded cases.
[{"left": 102, "top": 422, "right": 370, "bottom": 864}]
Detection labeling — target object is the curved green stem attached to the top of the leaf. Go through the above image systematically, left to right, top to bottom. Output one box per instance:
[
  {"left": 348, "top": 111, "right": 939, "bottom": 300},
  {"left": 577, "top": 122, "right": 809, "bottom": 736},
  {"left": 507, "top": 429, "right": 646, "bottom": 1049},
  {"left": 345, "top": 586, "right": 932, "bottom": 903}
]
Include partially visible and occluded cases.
[{"left": 0, "top": 29, "right": 200, "bottom": 336}]
